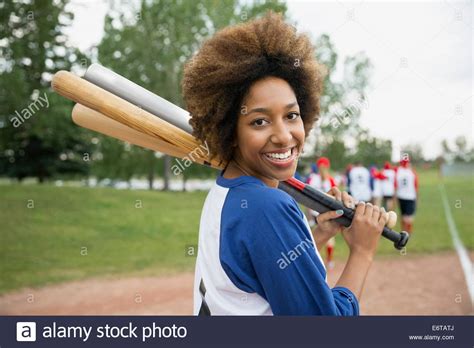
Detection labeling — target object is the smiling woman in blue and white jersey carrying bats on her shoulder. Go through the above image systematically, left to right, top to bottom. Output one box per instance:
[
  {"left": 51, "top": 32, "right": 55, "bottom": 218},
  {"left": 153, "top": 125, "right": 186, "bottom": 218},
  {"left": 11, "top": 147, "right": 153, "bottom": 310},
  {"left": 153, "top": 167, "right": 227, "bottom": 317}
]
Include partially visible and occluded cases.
[{"left": 183, "top": 13, "right": 386, "bottom": 315}]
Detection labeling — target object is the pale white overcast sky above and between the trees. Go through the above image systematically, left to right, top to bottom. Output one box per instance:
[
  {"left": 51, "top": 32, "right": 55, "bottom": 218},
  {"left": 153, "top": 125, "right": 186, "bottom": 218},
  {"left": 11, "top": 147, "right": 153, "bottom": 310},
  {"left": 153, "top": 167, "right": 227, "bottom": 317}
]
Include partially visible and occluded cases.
[{"left": 65, "top": 0, "right": 474, "bottom": 160}]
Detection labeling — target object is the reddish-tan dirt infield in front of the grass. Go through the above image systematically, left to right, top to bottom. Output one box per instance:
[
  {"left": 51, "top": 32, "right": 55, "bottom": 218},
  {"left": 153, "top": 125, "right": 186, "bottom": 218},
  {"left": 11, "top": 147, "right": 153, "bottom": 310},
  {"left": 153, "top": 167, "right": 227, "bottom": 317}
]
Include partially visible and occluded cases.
[{"left": 0, "top": 252, "right": 473, "bottom": 315}]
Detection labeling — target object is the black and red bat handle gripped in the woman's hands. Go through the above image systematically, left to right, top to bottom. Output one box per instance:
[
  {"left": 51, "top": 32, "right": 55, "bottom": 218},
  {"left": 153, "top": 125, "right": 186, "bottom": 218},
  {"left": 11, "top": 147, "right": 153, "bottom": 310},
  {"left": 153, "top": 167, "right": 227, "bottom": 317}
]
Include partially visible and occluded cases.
[{"left": 278, "top": 181, "right": 410, "bottom": 250}]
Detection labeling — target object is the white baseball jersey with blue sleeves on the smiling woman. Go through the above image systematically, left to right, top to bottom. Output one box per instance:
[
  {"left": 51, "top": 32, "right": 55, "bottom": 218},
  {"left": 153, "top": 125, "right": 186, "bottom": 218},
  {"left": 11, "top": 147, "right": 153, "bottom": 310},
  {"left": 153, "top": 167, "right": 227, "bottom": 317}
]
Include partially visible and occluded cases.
[{"left": 194, "top": 173, "right": 359, "bottom": 315}]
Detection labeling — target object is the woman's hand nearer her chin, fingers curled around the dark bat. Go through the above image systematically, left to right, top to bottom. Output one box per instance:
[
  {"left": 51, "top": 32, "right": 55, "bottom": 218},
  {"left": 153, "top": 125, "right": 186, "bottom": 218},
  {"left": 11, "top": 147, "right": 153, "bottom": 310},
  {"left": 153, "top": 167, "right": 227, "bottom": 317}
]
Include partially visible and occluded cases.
[{"left": 313, "top": 187, "right": 355, "bottom": 249}]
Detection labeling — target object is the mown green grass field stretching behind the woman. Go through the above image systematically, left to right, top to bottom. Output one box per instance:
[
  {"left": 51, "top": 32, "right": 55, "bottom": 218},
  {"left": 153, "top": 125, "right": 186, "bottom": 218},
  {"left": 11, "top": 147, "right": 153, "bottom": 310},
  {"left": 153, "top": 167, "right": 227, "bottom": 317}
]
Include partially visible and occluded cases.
[{"left": 0, "top": 172, "right": 474, "bottom": 293}]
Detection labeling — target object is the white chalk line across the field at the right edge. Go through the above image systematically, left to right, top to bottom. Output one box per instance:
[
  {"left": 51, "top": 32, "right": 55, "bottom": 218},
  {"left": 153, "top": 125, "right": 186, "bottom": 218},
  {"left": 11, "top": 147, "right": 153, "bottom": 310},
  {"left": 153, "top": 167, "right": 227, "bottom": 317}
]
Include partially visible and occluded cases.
[{"left": 439, "top": 184, "right": 474, "bottom": 306}]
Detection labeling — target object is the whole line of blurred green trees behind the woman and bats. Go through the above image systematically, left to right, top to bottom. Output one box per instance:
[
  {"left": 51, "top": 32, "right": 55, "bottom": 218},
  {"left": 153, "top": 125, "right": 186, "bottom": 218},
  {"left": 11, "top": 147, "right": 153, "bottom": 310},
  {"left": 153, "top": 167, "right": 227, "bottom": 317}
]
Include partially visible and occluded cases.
[{"left": 0, "top": 0, "right": 462, "bottom": 188}]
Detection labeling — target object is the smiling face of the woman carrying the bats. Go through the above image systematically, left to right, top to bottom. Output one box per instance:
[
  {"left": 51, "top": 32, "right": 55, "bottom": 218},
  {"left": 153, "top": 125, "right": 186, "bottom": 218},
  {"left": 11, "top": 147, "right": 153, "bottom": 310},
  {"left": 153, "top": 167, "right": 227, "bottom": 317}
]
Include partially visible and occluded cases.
[{"left": 234, "top": 77, "right": 305, "bottom": 187}]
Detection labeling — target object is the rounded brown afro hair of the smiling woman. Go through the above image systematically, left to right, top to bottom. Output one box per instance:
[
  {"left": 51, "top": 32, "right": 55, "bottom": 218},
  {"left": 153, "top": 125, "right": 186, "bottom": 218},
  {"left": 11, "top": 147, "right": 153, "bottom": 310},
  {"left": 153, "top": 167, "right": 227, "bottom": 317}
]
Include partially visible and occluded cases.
[{"left": 182, "top": 12, "right": 323, "bottom": 162}]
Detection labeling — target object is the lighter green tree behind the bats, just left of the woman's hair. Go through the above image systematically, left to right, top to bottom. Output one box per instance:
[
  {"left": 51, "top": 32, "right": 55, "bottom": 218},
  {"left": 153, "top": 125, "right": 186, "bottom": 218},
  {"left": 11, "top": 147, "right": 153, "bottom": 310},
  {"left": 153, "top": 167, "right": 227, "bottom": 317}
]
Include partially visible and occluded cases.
[{"left": 92, "top": 0, "right": 286, "bottom": 189}]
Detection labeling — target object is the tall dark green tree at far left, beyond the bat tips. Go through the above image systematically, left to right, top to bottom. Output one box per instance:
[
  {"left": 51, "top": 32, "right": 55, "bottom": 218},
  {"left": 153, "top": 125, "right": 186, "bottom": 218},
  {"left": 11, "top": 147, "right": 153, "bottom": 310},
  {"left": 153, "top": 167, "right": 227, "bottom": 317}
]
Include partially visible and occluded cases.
[{"left": 0, "top": 0, "right": 91, "bottom": 182}]
